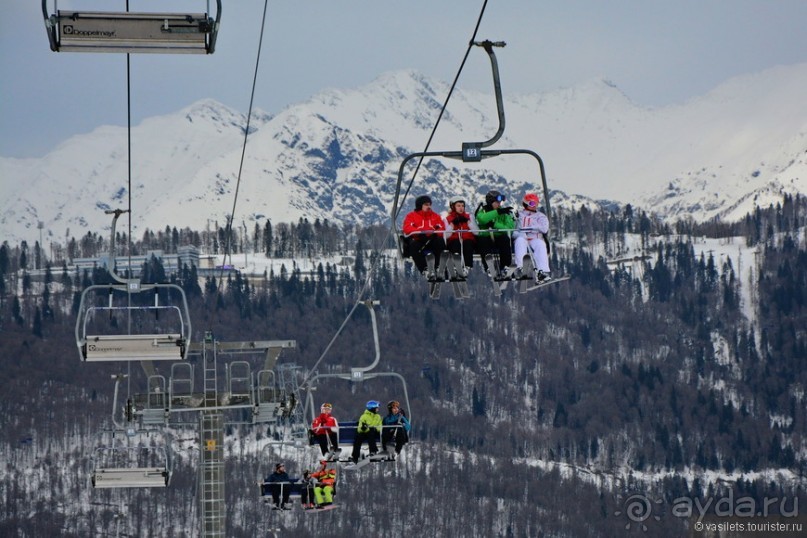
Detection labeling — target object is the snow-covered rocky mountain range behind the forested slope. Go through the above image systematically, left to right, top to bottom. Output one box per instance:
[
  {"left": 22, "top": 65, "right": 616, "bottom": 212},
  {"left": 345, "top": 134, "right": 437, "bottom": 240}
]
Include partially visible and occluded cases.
[{"left": 0, "top": 64, "right": 807, "bottom": 245}]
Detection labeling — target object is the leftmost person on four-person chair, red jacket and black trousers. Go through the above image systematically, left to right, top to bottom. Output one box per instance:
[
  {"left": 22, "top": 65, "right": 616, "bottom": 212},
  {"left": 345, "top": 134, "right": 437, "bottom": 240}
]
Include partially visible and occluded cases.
[{"left": 403, "top": 196, "right": 446, "bottom": 280}]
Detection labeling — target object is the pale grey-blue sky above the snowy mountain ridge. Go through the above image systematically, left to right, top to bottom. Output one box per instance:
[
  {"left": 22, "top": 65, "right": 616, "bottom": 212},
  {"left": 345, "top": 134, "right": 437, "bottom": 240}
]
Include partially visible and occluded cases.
[{"left": 0, "top": 0, "right": 807, "bottom": 157}]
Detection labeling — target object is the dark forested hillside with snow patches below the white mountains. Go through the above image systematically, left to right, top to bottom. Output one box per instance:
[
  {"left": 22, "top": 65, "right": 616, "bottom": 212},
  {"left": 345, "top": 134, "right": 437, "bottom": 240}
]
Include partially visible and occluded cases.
[{"left": 0, "top": 196, "right": 807, "bottom": 537}]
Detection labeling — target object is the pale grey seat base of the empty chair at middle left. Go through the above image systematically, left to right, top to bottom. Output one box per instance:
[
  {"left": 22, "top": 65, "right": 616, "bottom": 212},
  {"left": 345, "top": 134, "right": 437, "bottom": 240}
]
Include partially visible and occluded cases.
[{"left": 81, "top": 334, "right": 185, "bottom": 362}]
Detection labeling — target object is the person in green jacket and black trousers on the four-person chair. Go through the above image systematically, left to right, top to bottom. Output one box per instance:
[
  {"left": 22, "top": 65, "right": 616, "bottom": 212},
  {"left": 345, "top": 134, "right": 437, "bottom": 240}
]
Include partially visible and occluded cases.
[{"left": 475, "top": 191, "right": 516, "bottom": 276}]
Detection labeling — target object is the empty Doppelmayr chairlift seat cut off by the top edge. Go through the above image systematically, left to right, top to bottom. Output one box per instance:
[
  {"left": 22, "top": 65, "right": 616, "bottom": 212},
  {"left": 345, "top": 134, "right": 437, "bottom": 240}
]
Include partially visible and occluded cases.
[{"left": 42, "top": 0, "right": 221, "bottom": 54}]
